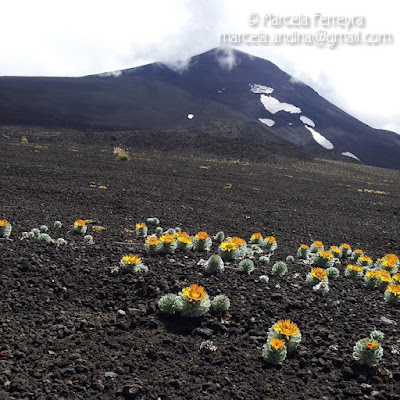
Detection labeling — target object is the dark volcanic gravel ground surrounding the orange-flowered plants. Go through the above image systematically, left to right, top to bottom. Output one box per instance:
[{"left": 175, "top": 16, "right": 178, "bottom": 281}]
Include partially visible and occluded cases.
[{"left": 0, "top": 130, "right": 400, "bottom": 400}]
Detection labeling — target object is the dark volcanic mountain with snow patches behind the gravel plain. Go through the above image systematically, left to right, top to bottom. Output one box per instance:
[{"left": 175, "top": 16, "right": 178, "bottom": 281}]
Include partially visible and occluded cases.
[{"left": 0, "top": 49, "right": 400, "bottom": 169}]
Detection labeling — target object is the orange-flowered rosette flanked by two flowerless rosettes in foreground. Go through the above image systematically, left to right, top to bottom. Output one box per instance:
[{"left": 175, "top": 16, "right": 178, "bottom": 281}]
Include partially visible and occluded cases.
[{"left": 176, "top": 283, "right": 211, "bottom": 317}]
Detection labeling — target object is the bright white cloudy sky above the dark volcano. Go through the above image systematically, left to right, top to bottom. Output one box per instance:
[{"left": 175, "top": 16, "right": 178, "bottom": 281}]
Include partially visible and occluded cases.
[{"left": 0, "top": 0, "right": 400, "bottom": 134}]
